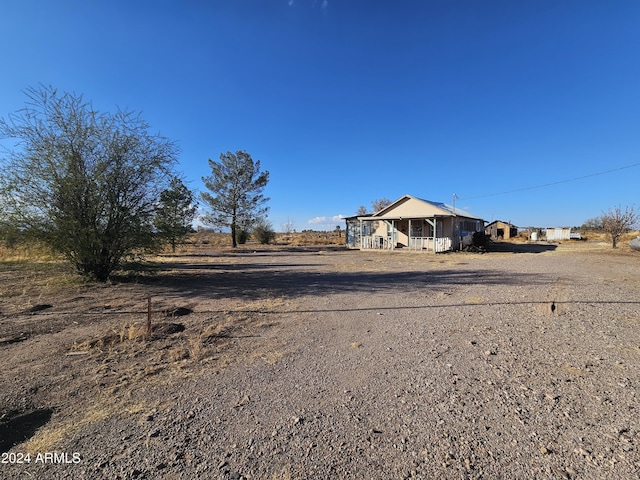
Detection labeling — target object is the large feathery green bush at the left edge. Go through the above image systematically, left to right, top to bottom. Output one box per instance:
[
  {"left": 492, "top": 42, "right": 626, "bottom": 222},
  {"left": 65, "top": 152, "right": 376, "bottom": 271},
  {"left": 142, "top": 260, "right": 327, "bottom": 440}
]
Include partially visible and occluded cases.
[{"left": 0, "top": 87, "right": 189, "bottom": 281}]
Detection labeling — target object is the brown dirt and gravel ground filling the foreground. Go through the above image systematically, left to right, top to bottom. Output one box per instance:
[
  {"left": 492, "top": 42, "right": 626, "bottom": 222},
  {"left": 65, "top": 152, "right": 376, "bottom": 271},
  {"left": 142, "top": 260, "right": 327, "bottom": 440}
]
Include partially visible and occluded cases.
[{"left": 0, "top": 242, "right": 640, "bottom": 479}]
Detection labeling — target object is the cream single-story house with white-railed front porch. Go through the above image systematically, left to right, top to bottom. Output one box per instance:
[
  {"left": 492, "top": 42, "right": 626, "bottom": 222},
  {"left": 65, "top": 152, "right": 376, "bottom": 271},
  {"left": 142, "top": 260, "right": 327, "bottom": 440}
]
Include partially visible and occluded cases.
[{"left": 345, "top": 195, "right": 484, "bottom": 253}]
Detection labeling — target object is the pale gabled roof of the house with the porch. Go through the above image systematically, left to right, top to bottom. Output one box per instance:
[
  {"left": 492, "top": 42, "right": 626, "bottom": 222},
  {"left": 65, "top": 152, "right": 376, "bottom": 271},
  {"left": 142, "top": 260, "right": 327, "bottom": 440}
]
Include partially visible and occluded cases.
[{"left": 358, "top": 195, "right": 483, "bottom": 220}]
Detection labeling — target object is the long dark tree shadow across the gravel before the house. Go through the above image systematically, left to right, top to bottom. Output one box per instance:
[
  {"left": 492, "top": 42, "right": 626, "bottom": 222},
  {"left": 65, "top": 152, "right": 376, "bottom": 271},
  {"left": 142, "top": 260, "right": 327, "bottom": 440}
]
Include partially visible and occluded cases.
[{"left": 119, "top": 261, "right": 551, "bottom": 299}]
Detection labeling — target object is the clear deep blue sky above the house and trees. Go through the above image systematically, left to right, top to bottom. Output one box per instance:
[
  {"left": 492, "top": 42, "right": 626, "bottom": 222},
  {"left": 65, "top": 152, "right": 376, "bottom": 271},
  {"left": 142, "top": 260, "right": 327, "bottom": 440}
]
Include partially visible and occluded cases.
[{"left": 0, "top": 0, "right": 640, "bottom": 230}]
